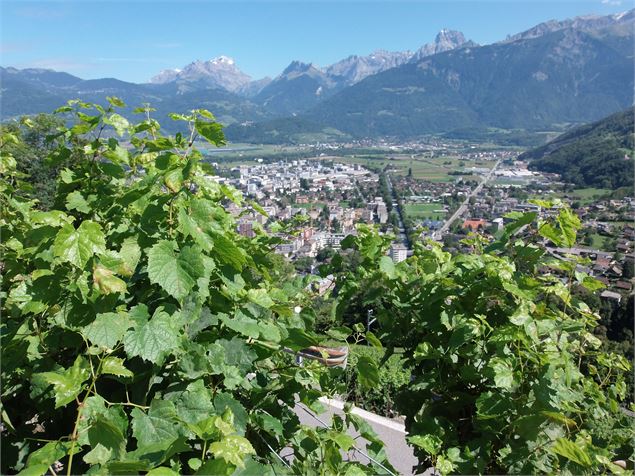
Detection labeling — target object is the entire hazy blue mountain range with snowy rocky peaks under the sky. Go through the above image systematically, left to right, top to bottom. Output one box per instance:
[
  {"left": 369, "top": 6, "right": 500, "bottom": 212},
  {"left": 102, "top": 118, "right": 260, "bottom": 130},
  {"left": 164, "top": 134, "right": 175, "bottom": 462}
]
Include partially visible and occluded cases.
[{"left": 0, "top": 10, "right": 635, "bottom": 143}]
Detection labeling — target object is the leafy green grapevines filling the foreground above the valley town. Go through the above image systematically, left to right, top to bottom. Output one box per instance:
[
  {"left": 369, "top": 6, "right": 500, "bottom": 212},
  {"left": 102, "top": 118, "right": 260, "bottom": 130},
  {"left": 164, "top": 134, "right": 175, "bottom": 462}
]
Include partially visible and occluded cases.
[{"left": 0, "top": 98, "right": 635, "bottom": 476}]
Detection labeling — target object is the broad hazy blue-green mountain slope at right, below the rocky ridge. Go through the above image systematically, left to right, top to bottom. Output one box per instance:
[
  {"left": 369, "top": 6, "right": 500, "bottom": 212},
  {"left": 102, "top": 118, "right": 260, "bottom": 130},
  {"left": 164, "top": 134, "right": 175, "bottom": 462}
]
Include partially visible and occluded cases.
[{"left": 308, "top": 27, "right": 633, "bottom": 137}]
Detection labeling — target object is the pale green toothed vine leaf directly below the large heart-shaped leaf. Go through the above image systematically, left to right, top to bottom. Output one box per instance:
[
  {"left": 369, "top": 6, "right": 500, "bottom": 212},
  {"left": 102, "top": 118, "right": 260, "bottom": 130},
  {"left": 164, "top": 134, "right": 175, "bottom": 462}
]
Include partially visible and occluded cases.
[{"left": 123, "top": 308, "right": 181, "bottom": 364}]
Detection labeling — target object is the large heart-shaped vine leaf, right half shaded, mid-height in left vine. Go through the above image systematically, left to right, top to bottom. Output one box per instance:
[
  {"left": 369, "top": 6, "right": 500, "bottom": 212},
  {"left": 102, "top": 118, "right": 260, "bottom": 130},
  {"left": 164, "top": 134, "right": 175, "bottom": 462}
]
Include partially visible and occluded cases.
[{"left": 148, "top": 240, "right": 205, "bottom": 300}]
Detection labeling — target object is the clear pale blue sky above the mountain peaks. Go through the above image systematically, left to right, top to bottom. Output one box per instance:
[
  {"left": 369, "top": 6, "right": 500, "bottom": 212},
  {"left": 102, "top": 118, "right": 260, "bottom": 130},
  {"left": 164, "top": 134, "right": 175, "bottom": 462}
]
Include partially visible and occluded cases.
[{"left": 0, "top": 0, "right": 634, "bottom": 82}]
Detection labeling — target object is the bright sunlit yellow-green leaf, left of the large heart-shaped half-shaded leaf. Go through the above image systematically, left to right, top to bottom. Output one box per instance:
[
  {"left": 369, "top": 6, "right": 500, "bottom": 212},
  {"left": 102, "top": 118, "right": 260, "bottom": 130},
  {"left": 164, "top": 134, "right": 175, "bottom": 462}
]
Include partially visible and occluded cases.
[{"left": 53, "top": 220, "right": 106, "bottom": 268}]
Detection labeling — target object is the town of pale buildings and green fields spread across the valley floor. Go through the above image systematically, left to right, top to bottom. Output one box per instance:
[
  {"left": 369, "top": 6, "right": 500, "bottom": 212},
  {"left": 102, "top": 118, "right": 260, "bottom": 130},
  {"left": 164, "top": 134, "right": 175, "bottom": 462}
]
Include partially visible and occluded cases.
[{"left": 207, "top": 143, "right": 635, "bottom": 305}]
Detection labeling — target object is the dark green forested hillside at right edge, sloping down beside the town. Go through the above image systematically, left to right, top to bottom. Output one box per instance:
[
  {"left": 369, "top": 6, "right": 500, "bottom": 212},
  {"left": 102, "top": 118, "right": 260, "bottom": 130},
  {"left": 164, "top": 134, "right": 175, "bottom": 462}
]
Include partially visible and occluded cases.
[{"left": 519, "top": 107, "right": 635, "bottom": 189}]
